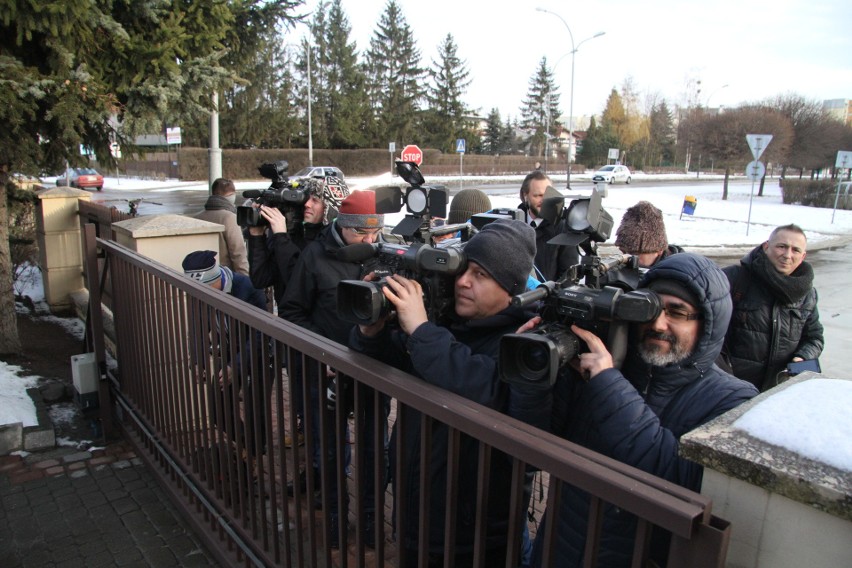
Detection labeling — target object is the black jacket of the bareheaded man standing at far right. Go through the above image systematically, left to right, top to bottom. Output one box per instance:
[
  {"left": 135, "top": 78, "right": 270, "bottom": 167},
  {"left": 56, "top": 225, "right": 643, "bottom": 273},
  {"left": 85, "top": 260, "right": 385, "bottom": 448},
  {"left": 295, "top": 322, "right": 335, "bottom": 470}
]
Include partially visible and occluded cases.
[{"left": 724, "top": 246, "right": 825, "bottom": 391}]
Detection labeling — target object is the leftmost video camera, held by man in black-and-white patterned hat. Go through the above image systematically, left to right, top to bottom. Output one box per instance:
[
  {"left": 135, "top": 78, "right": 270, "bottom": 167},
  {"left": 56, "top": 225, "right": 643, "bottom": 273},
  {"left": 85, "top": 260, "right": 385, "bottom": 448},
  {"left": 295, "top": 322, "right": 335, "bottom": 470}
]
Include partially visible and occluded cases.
[{"left": 237, "top": 160, "right": 310, "bottom": 227}]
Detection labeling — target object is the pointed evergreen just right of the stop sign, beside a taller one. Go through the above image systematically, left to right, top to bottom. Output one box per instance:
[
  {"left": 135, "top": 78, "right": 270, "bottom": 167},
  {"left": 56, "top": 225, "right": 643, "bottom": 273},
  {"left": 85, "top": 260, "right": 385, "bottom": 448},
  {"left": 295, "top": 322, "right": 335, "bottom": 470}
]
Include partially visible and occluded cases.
[{"left": 423, "top": 34, "right": 471, "bottom": 152}]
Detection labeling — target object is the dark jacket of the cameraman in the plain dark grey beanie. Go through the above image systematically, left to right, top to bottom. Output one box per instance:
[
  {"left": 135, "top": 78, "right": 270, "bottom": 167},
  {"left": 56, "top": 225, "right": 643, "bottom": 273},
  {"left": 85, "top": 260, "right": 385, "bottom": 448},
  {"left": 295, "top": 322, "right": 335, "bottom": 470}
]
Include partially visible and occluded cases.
[{"left": 350, "top": 307, "right": 541, "bottom": 554}]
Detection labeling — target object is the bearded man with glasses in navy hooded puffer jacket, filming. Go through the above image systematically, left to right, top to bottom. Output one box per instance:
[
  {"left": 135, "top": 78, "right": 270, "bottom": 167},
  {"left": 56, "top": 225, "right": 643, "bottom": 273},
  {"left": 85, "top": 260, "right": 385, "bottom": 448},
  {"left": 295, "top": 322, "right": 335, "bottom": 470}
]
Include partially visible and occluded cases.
[{"left": 533, "top": 253, "right": 757, "bottom": 566}]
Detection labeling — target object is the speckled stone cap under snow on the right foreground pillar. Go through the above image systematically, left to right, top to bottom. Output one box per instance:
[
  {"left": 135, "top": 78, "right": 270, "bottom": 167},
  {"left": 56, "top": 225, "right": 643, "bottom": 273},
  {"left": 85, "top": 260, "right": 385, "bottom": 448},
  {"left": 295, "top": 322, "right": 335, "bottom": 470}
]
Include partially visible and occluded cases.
[{"left": 680, "top": 372, "right": 852, "bottom": 521}]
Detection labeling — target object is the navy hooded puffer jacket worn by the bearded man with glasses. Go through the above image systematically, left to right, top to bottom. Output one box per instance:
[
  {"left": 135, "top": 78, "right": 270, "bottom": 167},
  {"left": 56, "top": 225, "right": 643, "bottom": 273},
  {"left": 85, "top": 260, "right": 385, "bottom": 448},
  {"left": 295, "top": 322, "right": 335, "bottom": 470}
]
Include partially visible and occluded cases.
[{"left": 533, "top": 253, "right": 757, "bottom": 567}]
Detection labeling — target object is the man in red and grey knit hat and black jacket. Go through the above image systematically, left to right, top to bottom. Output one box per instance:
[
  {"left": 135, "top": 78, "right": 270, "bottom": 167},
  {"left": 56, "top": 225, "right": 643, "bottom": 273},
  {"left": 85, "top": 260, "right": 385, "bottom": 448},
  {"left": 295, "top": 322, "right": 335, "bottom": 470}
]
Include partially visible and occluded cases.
[{"left": 278, "top": 191, "right": 389, "bottom": 548}]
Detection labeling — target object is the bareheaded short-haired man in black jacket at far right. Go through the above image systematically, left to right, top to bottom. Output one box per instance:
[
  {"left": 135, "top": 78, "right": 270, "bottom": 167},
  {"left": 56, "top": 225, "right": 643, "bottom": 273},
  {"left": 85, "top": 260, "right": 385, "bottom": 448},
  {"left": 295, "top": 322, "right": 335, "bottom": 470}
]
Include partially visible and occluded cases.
[{"left": 723, "top": 225, "right": 825, "bottom": 392}]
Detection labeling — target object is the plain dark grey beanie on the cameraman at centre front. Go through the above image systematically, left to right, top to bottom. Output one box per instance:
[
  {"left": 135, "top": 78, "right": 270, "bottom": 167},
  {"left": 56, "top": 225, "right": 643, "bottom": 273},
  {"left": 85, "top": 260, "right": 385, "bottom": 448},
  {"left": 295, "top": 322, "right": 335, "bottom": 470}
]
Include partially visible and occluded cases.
[{"left": 464, "top": 219, "right": 535, "bottom": 296}]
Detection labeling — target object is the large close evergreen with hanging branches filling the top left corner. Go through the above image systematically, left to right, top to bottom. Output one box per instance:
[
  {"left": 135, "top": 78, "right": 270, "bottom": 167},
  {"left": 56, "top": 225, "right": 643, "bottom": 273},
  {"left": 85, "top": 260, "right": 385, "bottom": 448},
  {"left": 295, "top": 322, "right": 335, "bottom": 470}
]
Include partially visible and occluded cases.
[{"left": 0, "top": 0, "right": 302, "bottom": 353}]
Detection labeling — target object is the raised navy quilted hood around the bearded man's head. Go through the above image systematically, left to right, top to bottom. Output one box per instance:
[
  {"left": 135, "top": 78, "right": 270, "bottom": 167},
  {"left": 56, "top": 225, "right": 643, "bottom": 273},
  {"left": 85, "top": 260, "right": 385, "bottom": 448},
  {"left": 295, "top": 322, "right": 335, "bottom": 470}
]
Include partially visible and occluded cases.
[{"left": 639, "top": 253, "right": 733, "bottom": 373}]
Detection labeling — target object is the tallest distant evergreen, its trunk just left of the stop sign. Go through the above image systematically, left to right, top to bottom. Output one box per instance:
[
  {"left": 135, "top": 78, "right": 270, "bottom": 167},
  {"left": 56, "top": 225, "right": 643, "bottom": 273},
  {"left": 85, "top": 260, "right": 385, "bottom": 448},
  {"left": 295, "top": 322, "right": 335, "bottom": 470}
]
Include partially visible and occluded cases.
[{"left": 366, "top": 0, "right": 424, "bottom": 146}]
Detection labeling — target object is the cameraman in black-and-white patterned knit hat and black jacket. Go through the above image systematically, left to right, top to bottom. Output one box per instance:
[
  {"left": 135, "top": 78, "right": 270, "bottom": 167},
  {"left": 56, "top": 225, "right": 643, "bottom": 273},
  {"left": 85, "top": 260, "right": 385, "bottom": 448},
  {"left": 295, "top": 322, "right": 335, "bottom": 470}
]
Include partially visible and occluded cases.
[{"left": 248, "top": 178, "right": 349, "bottom": 309}]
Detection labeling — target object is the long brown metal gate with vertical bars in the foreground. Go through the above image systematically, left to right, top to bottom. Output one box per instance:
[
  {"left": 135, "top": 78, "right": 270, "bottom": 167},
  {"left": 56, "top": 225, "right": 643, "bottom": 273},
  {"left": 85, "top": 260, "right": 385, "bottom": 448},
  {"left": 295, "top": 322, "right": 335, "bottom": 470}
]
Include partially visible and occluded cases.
[{"left": 85, "top": 228, "right": 730, "bottom": 567}]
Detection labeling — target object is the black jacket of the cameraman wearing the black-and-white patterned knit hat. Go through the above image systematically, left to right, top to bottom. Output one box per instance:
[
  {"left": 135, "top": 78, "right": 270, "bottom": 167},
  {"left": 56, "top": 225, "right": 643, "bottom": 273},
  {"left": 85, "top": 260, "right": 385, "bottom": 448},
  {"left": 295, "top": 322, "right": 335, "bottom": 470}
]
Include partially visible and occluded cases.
[{"left": 248, "top": 223, "right": 323, "bottom": 306}]
